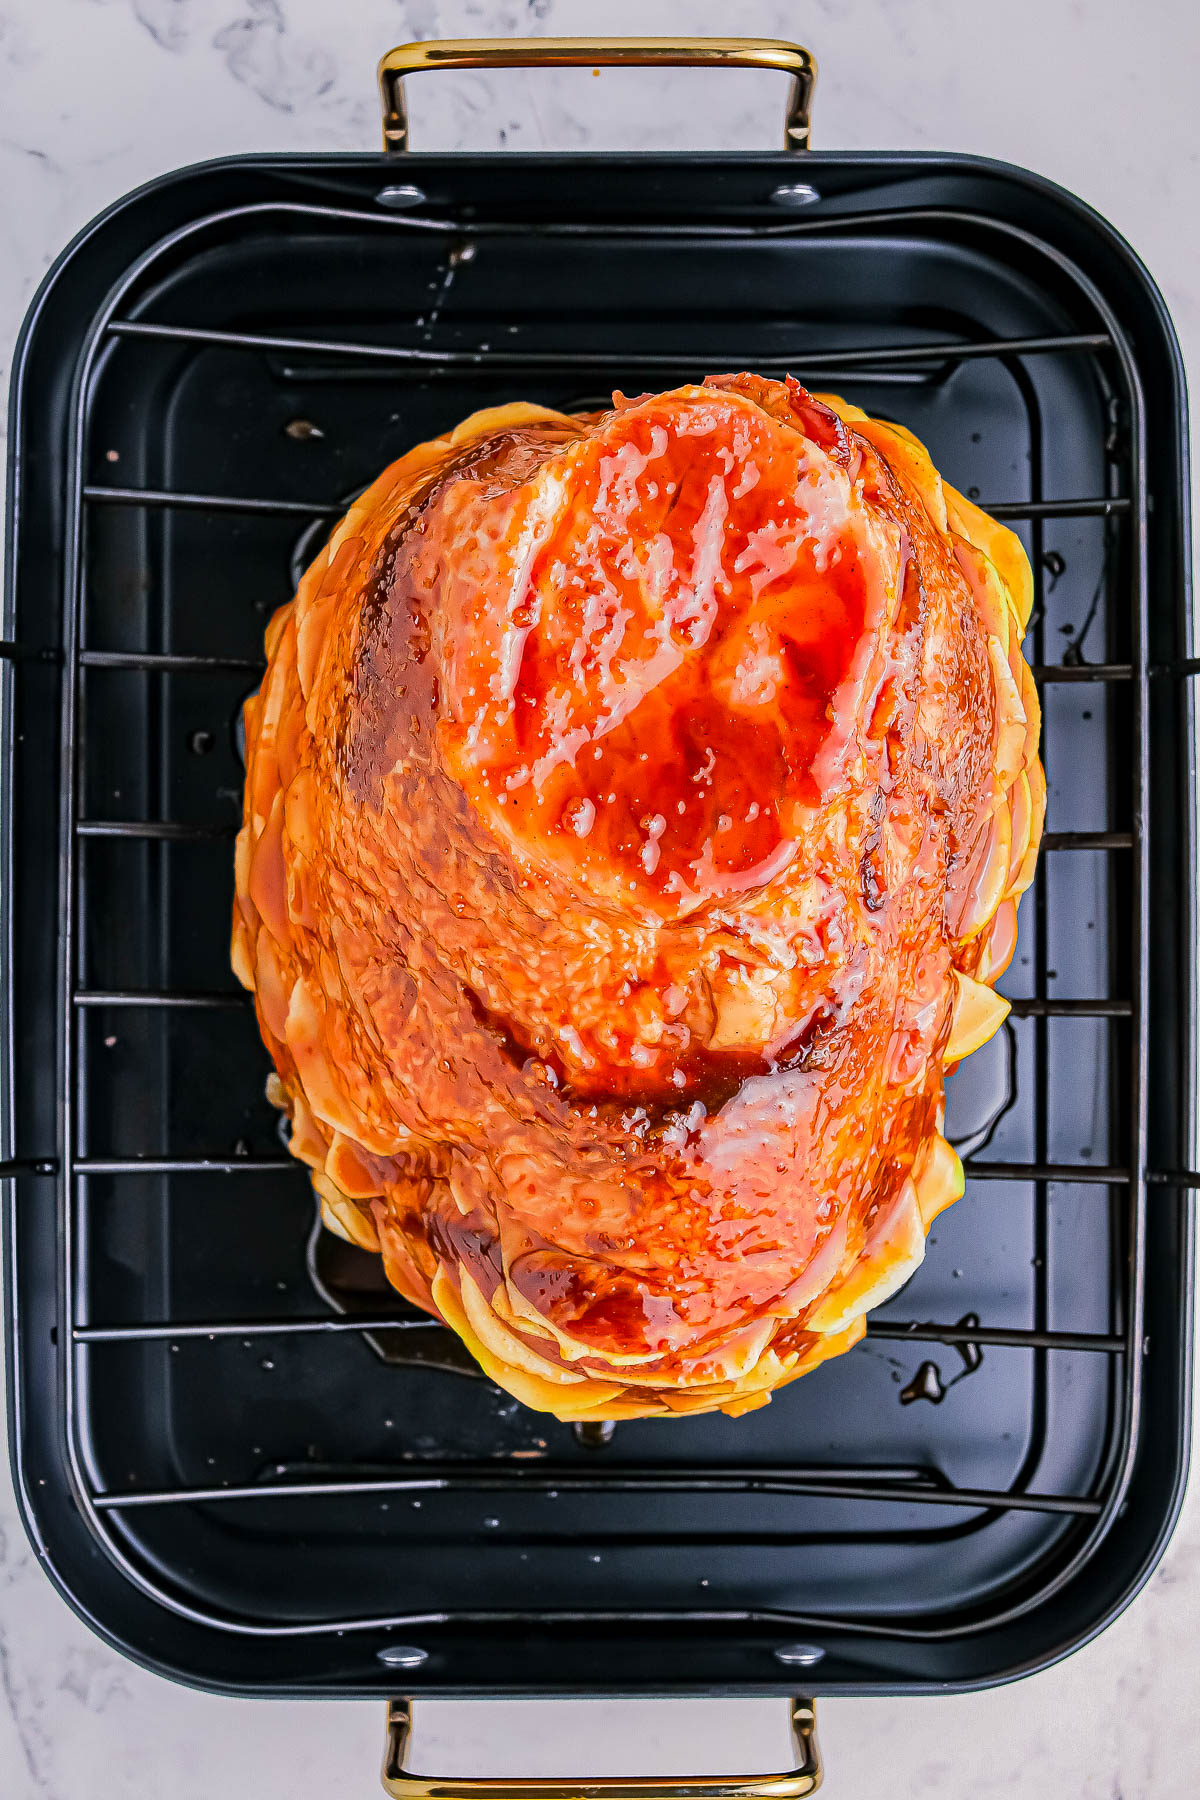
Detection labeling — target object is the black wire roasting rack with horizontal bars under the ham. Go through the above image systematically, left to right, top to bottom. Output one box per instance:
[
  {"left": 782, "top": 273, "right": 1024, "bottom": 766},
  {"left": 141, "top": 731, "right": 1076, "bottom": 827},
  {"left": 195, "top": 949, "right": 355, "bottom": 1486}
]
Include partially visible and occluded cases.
[{"left": 0, "top": 158, "right": 1200, "bottom": 1684}]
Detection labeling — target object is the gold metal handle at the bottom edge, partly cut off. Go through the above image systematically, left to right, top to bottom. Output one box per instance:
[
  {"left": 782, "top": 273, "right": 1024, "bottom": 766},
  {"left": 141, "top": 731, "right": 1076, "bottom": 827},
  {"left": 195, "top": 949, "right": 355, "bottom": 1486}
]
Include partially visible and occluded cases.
[{"left": 383, "top": 1699, "right": 820, "bottom": 1800}]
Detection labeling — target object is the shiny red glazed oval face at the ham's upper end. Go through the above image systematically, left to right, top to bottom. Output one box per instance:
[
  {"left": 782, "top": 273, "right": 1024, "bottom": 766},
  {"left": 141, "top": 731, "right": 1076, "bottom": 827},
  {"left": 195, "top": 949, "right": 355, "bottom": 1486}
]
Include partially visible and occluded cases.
[{"left": 441, "top": 394, "right": 885, "bottom": 914}]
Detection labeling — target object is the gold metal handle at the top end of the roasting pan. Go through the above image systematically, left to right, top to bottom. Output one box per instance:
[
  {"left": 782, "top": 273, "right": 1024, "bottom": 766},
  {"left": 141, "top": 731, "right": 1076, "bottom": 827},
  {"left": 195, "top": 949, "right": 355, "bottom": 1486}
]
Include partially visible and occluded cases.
[{"left": 380, "top": 38, "right": 817, "bottom": 155}]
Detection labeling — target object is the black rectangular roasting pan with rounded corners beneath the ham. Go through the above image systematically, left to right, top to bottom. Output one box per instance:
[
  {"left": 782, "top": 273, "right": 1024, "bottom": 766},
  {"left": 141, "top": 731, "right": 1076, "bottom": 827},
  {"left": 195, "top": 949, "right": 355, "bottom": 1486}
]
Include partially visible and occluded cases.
[{"left": 0, "top": 28, "right": 1198, "bottom": 1791}]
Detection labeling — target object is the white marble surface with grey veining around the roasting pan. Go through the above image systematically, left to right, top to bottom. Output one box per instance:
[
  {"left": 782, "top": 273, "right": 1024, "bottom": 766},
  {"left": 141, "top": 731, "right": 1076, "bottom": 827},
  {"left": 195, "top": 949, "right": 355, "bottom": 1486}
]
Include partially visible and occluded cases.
[{"left": 0, "top": 0, "right": 1200, "bottom": 1800}]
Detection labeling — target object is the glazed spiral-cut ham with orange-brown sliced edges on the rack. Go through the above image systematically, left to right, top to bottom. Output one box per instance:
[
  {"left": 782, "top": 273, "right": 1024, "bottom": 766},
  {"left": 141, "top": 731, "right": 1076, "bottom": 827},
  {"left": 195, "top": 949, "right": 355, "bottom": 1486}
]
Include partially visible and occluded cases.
[{"left": 232, "top": 374, "right": 1045, "bottom": 1420}]
